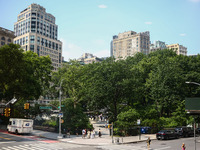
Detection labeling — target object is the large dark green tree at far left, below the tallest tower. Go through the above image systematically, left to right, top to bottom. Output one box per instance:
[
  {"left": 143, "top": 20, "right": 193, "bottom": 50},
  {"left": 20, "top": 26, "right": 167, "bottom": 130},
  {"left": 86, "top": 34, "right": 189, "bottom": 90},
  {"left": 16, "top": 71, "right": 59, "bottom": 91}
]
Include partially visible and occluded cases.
[{"left": 0, "top": 44, "right": 52, "bottom": 115}]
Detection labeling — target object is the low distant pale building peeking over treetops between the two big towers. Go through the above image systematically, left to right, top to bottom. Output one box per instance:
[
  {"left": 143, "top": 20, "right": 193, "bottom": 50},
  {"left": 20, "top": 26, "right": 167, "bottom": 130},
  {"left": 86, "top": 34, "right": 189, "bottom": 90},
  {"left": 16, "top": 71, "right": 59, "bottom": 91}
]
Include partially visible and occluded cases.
[{"left": 78, "top": 53, "right": 102, "bottom": 64}]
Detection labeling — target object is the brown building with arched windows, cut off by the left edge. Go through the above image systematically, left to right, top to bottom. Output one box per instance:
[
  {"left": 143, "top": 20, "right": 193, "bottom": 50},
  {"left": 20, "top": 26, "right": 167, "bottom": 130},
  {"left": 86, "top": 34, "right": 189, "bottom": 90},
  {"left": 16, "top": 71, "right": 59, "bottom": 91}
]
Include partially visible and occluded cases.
[{"left": 0, "top": 27, "right": 15, "bottom": 47}]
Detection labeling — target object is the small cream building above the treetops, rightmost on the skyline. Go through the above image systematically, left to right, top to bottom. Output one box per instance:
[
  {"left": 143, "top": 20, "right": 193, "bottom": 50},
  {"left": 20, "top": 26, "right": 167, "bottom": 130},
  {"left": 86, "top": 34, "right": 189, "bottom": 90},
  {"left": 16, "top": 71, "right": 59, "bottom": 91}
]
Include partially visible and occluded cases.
[{"left": 167, "top": 44, "right": 187, "bottom": 56}]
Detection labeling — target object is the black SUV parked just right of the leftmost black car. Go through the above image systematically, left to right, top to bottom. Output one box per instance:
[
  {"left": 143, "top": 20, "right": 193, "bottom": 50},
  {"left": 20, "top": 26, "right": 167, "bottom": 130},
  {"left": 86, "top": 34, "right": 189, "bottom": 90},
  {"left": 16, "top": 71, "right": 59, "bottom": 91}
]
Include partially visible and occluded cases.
[{"left": 175, "top": 126, "right": 194, "bottom": 137}]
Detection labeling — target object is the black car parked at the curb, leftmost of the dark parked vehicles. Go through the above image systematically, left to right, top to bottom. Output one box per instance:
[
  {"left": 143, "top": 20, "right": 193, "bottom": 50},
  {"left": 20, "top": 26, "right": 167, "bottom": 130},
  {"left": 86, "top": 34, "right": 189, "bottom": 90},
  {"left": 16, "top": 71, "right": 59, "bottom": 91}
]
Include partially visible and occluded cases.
[{"left": 156, "top": 130, "right": 179, "bottom": 140}]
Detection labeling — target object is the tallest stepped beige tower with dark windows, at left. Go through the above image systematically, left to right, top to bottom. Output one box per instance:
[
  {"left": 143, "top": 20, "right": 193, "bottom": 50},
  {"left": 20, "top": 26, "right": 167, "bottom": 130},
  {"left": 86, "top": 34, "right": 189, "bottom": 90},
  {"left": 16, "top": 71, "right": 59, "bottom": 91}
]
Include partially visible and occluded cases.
[{"left": 14, "top": 4, "right": 62, "bottom": 71}]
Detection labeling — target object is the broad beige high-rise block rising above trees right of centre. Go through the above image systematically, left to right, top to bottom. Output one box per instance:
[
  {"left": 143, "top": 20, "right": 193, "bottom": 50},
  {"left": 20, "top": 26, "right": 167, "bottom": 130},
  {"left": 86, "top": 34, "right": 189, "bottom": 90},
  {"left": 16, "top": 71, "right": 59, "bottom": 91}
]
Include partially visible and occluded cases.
[{"left": 111, "top": 31, "right": 150, "bottom": 59}]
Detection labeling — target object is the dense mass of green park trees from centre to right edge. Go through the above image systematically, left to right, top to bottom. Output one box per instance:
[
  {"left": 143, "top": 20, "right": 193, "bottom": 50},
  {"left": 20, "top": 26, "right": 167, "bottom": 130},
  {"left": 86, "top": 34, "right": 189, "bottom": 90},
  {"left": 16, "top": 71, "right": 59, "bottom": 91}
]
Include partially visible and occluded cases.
[{"left": 49, "top": 50, "right": 200, "bottom": 134}]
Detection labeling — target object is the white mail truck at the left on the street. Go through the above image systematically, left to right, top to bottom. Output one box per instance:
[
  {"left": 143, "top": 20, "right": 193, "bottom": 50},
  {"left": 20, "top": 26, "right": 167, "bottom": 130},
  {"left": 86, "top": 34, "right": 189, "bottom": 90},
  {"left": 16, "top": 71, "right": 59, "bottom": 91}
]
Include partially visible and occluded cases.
[{"left": 7, "top": 118, "right": 33, "bottom": 134}]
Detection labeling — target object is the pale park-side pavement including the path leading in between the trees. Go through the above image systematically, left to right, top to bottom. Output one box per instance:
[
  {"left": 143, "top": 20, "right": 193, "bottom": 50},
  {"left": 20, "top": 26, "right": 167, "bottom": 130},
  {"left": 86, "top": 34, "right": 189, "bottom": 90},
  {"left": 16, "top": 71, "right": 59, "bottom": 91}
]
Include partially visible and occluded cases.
[{"left": 32, "top": 121, "right": 156, "bottom": 146}]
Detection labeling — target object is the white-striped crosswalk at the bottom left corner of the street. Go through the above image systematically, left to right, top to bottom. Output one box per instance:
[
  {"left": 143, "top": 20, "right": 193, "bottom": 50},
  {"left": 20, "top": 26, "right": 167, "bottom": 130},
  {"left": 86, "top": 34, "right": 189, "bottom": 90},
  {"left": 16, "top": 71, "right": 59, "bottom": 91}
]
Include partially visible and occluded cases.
[{"left": 0, "top": 144, "right": 63, "bottom": 150}]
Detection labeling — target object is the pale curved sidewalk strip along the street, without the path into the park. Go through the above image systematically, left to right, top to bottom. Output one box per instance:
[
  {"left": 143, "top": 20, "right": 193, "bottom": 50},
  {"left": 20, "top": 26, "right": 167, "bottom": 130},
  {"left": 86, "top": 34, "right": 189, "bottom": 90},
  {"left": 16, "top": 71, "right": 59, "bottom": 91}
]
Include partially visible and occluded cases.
[{"left": 32, "top": 130, "right": 156, "bottom": 145}]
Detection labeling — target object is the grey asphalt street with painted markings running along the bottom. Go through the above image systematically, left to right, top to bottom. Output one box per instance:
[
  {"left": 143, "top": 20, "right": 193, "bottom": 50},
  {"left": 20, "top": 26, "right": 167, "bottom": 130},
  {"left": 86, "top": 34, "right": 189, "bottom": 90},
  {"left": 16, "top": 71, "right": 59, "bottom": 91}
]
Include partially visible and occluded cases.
[{"left": 0, "top": 132, "right": 200, "bottom": 150}]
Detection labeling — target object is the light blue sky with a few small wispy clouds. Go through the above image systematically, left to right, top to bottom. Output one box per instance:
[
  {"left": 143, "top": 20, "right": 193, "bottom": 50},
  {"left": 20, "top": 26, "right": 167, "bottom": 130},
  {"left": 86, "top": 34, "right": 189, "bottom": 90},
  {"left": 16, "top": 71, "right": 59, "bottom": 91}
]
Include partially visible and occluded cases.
[{"left": 0, "top": 0, "right": 200, "bottom": 60}]
